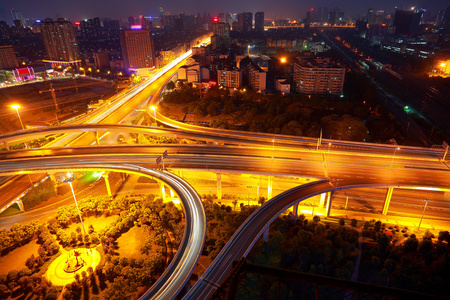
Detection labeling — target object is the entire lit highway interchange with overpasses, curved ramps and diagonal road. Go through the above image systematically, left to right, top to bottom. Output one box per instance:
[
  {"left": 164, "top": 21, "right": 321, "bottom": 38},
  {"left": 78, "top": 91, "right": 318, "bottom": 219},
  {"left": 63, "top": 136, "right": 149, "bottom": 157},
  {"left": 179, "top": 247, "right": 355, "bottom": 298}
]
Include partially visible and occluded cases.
[{"left": 0, "top": 41, "right": 450, "bottom": 299}]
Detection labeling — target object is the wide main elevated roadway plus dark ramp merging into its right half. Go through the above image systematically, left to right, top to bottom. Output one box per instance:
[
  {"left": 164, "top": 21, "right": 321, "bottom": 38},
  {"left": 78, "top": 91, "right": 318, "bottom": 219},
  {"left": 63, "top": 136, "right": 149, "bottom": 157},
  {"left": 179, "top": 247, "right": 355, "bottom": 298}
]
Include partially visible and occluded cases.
[{"left": 0, "top": 145, "right": 450, "bottom": 299}]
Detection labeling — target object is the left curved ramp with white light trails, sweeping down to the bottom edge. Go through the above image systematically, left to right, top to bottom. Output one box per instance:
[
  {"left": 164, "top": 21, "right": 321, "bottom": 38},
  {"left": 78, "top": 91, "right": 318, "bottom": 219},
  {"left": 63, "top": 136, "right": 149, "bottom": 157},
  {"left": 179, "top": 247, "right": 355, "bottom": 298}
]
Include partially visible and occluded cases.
[{"left": 0, "top": 157, "right": 206, "bottom": 299}]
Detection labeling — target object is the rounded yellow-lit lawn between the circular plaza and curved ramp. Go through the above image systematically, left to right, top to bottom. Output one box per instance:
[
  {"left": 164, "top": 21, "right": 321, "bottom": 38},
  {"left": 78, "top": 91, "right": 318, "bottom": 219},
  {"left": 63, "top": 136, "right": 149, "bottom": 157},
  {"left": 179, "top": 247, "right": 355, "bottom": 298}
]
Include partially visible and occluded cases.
[{"left": 117, "top": 226, "right": 149, "bottom": 259}]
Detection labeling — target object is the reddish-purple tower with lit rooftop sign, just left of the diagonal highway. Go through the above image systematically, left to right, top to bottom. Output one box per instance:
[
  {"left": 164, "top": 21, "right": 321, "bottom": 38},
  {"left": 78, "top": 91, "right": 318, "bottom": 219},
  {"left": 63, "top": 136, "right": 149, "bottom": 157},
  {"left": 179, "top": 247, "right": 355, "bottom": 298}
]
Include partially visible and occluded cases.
[{"left": 120, "top": 27, "right": 156, "bottom": 70}]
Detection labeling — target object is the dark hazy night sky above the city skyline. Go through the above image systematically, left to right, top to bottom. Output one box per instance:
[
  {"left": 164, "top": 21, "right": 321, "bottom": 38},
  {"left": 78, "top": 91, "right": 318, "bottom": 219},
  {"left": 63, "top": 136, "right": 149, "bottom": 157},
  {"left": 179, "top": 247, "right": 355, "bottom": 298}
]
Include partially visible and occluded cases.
[{"left": 0, "top": 0, "right": 449, "bottom": 23}]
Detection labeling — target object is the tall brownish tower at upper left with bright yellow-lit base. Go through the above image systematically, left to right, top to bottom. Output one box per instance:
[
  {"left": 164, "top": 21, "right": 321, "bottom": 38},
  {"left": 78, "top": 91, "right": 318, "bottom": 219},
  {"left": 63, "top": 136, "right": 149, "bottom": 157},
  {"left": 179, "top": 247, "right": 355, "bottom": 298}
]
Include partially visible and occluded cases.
[{"left": 41, "top": 18, "right": 81, "bottom": 67}]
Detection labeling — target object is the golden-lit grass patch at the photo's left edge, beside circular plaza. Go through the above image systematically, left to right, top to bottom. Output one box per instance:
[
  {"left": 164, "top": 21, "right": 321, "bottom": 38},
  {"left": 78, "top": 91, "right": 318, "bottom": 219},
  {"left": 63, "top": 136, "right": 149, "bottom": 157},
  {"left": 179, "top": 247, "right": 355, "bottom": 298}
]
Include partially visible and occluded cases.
[{"left": 0, "top": 240, "right": 40, "bottom": 274}]
